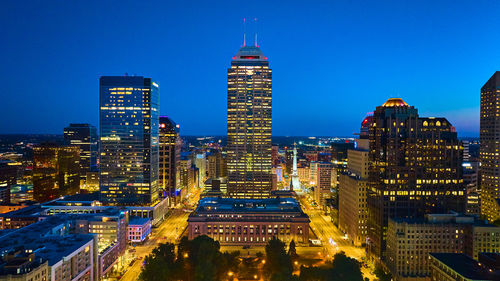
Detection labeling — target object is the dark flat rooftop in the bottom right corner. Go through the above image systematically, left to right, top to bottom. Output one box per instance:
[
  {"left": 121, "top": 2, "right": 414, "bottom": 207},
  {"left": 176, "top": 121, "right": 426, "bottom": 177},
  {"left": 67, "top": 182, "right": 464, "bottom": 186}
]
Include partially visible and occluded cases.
[{"left": 430, "top": 253, "right": 500, "bottom": 280}]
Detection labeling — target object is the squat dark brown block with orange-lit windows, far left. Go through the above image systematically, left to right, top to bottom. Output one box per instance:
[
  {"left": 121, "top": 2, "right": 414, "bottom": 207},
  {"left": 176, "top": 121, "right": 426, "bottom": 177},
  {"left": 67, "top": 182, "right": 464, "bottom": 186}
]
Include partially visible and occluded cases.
[{"left": 33, "top": 144, "right": 80, "bottom": 202}]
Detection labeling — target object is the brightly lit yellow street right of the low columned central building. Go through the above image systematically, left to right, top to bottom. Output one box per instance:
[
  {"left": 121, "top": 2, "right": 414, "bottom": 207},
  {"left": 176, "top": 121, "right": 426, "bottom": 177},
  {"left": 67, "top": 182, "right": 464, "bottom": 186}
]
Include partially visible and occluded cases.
[{"left": 298, "top": 196, "right": 375, "bottom": 280}]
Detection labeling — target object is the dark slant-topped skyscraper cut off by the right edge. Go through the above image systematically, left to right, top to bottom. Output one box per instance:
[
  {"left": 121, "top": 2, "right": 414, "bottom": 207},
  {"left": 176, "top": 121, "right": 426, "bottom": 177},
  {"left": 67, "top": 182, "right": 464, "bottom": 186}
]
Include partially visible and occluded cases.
[{"left": 480, "top": 71, "right": 500, "bottom": 222}]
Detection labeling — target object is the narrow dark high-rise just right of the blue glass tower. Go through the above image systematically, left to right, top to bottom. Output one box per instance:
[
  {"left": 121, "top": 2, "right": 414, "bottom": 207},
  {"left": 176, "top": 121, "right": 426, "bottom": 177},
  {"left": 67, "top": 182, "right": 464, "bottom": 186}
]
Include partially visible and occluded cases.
[{"left": 159, "top": 116, "right": 182, "bottom": 204}]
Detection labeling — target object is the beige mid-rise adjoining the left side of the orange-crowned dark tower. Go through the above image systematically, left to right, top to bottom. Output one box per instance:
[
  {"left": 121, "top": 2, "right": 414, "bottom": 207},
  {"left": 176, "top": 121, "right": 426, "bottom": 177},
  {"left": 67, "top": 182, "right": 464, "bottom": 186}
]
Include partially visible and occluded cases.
[{"left": 338, "top": 138, "right": 369, "bottom": 246}]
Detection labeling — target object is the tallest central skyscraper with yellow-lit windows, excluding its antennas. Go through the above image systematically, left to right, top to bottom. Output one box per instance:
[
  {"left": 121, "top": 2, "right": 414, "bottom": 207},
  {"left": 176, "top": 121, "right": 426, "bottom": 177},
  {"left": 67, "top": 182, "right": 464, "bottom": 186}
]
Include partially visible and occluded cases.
[{"left": 227, "top": 43, "right": 272, "bottom": 198}]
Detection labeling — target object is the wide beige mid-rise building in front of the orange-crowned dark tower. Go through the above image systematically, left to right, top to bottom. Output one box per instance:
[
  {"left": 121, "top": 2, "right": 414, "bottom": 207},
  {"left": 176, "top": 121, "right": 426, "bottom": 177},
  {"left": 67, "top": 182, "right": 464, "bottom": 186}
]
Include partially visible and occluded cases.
[{"left": 386, "top": 213, "right": 500, "bottom": 281}]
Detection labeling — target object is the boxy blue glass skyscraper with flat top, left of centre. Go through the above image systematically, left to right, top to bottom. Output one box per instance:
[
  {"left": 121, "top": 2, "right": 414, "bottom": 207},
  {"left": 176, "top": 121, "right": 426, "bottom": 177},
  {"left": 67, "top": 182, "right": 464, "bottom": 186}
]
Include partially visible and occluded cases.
[{"left": 99, "top": 76, "right": 159, "bottom": 205}]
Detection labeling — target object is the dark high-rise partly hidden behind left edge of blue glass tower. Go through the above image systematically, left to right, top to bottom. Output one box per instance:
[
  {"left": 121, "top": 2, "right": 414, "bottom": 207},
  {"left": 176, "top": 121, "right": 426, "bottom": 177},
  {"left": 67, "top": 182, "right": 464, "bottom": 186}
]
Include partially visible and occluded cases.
[{"left": 64, "top": 124, "right": 97, "bottom": 182}]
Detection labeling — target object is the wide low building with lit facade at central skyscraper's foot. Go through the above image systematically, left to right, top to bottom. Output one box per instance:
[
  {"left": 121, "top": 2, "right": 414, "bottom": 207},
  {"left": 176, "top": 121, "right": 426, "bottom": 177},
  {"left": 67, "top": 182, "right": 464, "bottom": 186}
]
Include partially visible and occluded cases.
[{"left": 188, "top": 197, "right": 309, "bottom": 245}]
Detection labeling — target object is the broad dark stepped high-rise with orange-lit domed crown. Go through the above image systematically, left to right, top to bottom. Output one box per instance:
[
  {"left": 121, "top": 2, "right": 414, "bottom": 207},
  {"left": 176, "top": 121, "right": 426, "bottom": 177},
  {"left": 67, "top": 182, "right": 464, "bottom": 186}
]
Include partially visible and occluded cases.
[{"left": 367, "top": 98, "right": 465, "bottom": 259}]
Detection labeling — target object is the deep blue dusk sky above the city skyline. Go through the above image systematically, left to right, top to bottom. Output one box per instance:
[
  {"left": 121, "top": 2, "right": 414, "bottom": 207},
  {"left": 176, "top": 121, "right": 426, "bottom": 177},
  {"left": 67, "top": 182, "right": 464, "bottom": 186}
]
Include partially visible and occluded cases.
[{"left": 0, "top": 0, "right": 500, "bottom": 136}]
